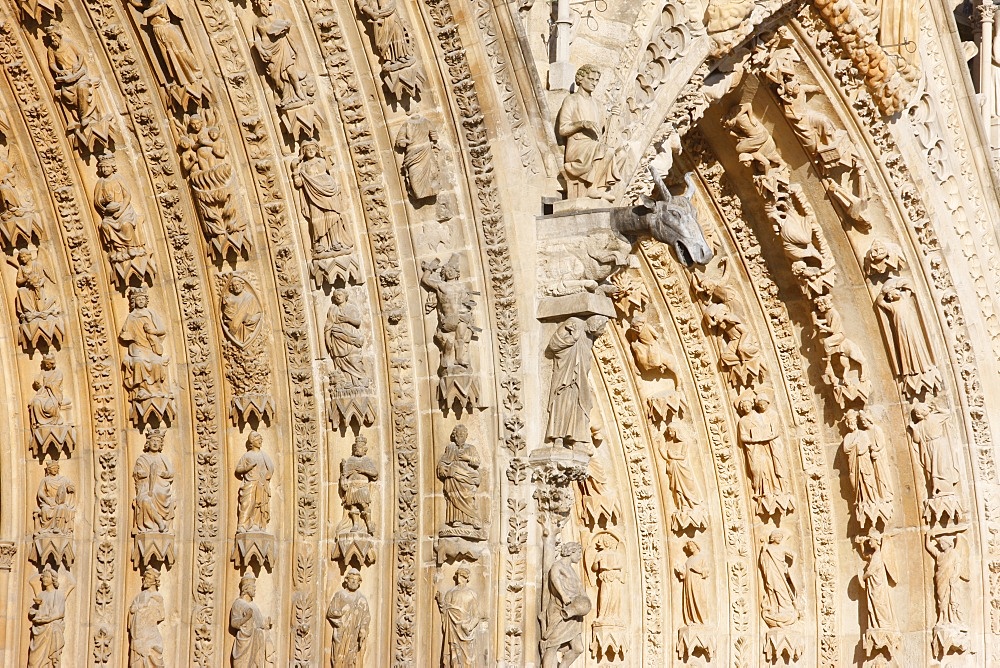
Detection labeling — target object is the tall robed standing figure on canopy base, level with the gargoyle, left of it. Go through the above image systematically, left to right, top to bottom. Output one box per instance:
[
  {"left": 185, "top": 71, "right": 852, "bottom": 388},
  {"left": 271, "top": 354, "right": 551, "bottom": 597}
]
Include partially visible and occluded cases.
[{"left": 292, "top": 139, "right": 364, "bottom": 285}]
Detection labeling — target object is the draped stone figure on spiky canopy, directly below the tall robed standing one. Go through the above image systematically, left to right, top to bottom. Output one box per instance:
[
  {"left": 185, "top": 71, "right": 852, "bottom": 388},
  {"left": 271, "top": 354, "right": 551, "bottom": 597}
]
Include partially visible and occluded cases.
[{"left": 323, "top": 288, "right": 375, "bottom": 428}]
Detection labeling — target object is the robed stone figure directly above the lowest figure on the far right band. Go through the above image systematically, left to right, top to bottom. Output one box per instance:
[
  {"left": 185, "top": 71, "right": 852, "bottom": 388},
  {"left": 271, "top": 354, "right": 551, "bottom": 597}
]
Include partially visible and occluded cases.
[{"left": 909, "top": 403, "right": 965, "bottom": 523}]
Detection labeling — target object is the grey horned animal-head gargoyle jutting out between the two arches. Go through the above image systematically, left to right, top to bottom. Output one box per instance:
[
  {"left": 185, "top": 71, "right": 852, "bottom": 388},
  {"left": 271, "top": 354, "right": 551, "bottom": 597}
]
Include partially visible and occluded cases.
[{"left": 612, "top": 165, "right": 714, "bottom": 267}]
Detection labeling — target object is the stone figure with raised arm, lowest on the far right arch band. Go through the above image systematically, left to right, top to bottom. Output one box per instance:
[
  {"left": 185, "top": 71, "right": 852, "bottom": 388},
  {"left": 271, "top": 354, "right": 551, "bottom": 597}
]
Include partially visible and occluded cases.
[{"left": 925, "top": 534, "right": 971, "bottom": 660}]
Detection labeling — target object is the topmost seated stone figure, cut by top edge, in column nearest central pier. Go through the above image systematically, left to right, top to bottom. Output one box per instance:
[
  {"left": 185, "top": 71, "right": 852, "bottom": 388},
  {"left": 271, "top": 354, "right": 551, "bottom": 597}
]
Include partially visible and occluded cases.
[{"left": 355, "top": 0, "right": 427, "bottom": 102}]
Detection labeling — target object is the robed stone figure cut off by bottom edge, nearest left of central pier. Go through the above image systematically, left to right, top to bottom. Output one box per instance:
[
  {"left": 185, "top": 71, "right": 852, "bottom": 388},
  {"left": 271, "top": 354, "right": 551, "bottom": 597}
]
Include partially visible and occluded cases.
[{"left": 434, "top": 567, "right": 486, "bottom": 668}]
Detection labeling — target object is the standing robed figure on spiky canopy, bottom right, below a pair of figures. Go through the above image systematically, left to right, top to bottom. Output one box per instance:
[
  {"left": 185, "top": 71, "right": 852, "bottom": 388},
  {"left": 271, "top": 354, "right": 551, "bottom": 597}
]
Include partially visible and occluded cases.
[{"left": 758, "top": 529, "right": 804, "bottom": 663}]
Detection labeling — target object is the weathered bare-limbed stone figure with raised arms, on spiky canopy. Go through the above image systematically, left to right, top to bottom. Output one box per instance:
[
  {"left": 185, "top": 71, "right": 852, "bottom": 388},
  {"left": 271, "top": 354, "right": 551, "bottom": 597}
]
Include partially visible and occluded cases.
[{"left": 420, "top": 254, "right": 480, "bottom": 410}]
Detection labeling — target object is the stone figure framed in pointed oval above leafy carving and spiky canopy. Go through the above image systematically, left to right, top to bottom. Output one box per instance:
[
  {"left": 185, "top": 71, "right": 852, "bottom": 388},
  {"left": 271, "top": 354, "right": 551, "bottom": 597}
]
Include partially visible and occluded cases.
[{"left": 218, "top": 272, "right": 274, "bottom": 425}]
